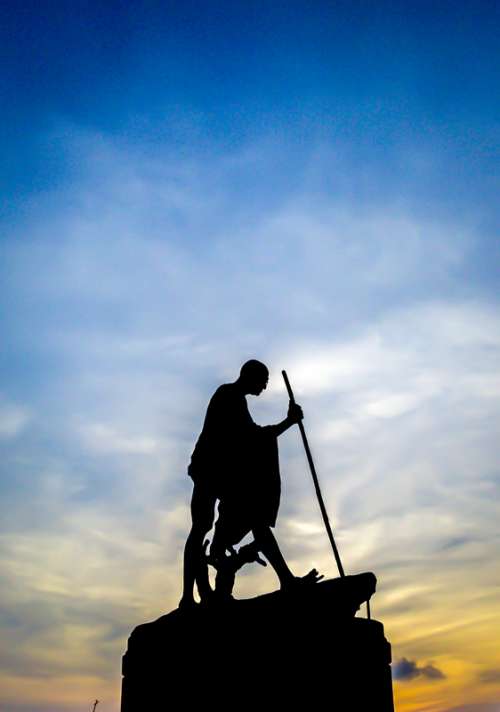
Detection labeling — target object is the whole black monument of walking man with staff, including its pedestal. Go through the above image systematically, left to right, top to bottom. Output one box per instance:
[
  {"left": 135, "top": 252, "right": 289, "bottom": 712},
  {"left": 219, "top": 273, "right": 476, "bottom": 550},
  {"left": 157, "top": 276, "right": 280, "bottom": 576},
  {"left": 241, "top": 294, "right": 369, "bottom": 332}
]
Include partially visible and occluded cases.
[{"left": 121, "top": 361, "right": 394, "bottom": 712}]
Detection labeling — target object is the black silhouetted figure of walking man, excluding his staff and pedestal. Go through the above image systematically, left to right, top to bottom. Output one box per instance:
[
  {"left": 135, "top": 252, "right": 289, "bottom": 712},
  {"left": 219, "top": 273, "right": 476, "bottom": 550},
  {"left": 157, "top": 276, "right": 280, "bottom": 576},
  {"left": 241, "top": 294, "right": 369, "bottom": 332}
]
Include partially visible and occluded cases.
[{"left": 179, "top": 360, "right": 318, "bottom": 607}]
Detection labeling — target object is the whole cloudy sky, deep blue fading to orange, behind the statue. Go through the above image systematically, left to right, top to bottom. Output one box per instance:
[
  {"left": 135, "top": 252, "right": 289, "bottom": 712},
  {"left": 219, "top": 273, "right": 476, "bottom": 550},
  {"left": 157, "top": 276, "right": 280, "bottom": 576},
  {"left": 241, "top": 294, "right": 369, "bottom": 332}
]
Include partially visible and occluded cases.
[{"left": 0, "top": 0, "right": 500, "bottom": 712}]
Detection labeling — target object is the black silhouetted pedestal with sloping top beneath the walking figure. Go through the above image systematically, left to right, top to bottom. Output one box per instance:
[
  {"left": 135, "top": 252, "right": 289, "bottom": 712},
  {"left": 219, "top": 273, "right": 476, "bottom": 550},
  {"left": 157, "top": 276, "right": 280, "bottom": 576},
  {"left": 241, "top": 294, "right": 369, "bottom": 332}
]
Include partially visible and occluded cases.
[{"left": 121, "top": 573, "right": 394, "bottom": 712}]
